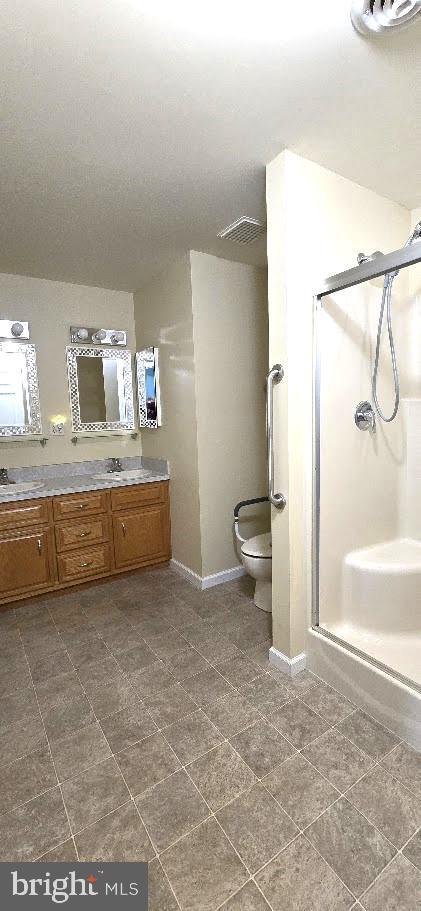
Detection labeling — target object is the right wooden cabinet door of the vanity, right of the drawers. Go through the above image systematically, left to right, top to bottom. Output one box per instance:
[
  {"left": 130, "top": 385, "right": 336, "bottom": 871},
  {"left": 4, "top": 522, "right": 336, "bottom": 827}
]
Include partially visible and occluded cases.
[{"left": 113, "top": 503, "right": 169, "bottom": 569}]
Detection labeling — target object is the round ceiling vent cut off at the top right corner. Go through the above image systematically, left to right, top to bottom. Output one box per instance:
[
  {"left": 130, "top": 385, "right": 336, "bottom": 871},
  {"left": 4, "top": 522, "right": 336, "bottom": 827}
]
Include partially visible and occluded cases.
[{"left": 351, "top": 0, "right": 421, "bottom": 35}]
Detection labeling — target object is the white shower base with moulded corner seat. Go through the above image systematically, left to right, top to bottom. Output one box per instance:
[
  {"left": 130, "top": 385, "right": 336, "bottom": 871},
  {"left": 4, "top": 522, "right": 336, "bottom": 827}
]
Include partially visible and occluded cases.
[{"left": 322, "top": 538, "right": 421, "bottom": 686}]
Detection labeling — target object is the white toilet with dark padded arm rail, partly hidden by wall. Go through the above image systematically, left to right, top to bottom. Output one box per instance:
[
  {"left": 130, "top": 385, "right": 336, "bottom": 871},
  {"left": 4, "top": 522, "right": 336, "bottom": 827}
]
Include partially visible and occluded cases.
[{"left": 234, "top": 497, "right": 272, "bottom": 613}]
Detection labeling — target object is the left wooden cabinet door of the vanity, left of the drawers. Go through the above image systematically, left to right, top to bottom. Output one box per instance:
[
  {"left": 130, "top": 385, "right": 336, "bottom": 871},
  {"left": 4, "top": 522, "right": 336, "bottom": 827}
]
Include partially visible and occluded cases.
[{"left": 0, "top": 528, "right": 54, "bottom": 599}]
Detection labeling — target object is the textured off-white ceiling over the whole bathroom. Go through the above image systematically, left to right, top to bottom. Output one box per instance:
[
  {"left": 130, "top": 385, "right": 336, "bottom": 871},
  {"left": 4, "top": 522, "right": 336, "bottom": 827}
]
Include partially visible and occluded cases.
[{"left": 0, "top": 0, "right": 421, "bottom": 290}]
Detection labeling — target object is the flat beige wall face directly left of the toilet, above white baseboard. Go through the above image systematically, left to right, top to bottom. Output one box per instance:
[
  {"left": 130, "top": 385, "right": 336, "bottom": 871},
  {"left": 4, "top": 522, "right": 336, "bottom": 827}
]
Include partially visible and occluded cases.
[{"left": 191, "top": 252, "right": 270, "bottom": 576}]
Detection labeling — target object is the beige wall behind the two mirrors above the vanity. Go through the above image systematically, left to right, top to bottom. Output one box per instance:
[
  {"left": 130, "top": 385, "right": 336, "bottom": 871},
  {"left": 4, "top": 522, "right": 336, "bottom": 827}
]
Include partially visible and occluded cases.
[{"left": 0, "top": 274, "right": 141, "bottom": 467}]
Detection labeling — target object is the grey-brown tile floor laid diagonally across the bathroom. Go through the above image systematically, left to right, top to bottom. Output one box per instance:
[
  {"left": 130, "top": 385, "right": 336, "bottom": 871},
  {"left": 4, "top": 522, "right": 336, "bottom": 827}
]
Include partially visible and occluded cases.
[{"left": 0, "top": 567, "right": 421, "bottom": 911}]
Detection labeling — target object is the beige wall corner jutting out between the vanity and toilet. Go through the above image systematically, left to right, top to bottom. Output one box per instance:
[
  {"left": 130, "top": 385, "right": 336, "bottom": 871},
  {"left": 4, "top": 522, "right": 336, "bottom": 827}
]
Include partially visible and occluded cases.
[{"left": 134, "top": 252, "right": 269, "bottom": 576}]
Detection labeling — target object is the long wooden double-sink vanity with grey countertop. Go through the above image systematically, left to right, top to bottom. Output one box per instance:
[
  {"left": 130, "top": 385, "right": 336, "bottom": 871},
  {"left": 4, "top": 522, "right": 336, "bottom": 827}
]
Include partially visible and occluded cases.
[{"left": 0, "top": 472, "right": 170, "bottom": 604}]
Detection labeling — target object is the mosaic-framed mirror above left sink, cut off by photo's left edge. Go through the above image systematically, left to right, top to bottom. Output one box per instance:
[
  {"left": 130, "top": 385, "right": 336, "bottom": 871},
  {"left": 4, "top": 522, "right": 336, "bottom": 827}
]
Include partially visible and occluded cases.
[{"left": 0, "top": 342, "right": 42, "bottom": 437}]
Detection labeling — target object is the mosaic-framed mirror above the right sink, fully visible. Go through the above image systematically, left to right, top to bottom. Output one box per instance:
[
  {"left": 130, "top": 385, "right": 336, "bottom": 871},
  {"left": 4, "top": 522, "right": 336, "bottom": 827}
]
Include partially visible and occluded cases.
[{"left": 67, "top": 346, "right": 134, "bottom": 433}]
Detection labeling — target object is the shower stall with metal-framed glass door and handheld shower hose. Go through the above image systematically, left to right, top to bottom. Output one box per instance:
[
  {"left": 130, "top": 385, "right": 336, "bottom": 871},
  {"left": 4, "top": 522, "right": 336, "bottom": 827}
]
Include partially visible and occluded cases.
[{"left": 312, "top": 242, "right": 421, "bottom": 732}]
